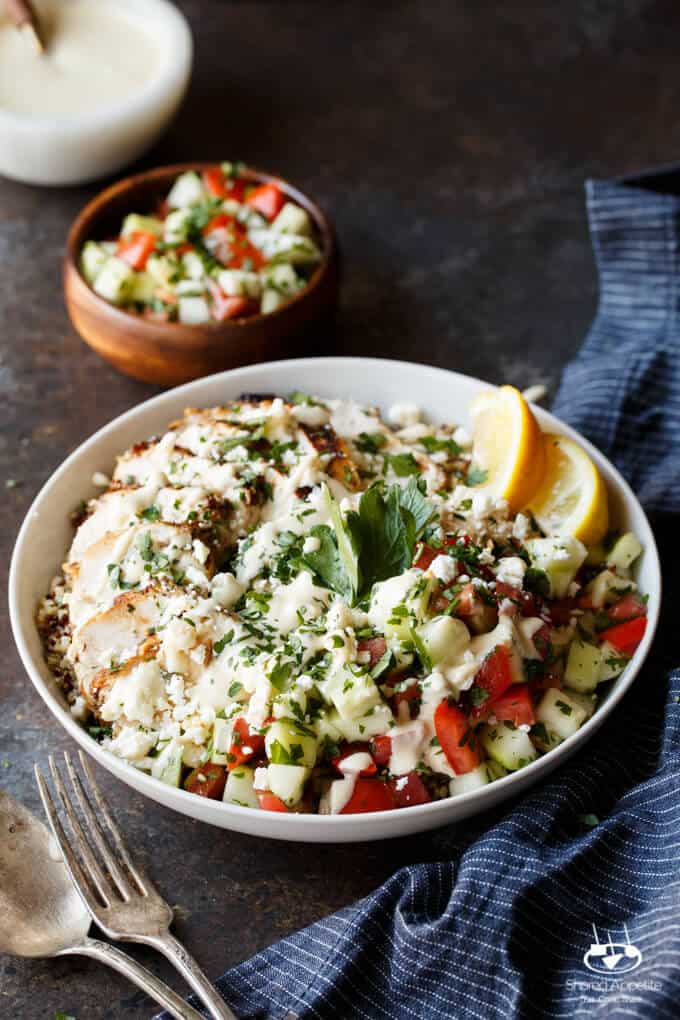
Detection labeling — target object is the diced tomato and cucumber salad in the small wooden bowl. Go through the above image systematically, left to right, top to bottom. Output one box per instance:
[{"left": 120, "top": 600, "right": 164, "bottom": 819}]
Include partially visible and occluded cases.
[{"left": 81, "top": 163, "right": 322, "bottom": 325}]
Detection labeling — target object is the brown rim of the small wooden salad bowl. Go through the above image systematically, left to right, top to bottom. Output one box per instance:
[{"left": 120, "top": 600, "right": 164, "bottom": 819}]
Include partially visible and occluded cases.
[{"left": 64, "top": 160, "right": 337, "bottom": 334}]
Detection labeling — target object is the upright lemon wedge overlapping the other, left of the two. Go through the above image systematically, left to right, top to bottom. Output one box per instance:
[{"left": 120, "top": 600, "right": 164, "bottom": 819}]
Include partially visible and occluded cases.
[{"left": 470, "top": 386, "right": 545, "bottom": 510}]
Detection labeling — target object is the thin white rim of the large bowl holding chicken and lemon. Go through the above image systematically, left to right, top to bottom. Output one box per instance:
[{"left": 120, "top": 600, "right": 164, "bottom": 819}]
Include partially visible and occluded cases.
[{"left": 9, "top": 357, "right": 662, "bottom": 828}]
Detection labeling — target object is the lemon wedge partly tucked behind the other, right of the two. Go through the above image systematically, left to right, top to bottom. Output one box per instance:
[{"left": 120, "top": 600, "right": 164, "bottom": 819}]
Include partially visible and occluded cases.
[{"left": 528, "top": 434, "right": 609, "bottom": 546}]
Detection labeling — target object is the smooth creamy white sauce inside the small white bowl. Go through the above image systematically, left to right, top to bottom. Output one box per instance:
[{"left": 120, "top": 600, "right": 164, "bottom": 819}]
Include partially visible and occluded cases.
[{"left": 0, "top": 0, "right": 161, "bottom": 117}]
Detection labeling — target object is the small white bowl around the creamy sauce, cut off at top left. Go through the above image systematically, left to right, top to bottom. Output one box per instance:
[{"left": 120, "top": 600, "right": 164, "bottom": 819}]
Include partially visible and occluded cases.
[{"left": 0, "top": 0, "right": 193, "bottom": 186}]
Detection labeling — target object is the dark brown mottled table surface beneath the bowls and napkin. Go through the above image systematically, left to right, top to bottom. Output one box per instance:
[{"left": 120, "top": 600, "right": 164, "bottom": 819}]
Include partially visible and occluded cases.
[{"left": 0, "top": 0, "right": 680, "bottom": 1020}]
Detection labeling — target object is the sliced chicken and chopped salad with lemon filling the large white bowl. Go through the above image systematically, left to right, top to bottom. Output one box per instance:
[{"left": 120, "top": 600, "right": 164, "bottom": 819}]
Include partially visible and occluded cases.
[{"left": 39, "top": 388, "right": 646, "bottom": 814}]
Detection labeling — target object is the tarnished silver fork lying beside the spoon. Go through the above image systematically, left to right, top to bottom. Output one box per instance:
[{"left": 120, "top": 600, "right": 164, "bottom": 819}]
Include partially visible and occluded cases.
[{"left": 35, "top": 751, "right": 237, "bottom": 1020}]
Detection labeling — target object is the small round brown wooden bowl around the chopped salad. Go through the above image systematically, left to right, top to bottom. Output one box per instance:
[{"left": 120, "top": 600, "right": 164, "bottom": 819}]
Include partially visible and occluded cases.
[{"left": 64, "top": 163, "right": 338, "bottom": 386}]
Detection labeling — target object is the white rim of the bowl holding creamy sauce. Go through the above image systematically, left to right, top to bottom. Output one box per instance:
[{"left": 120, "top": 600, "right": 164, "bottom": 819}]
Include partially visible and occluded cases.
[{"left": 0, "top": 0, "right": 194, "bottom": 134}]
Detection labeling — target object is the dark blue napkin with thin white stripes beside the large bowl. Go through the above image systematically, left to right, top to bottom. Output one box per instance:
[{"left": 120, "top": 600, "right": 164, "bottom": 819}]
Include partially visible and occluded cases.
[{"left": 155, "top": 171, "right": 680, "bottom": 1020}]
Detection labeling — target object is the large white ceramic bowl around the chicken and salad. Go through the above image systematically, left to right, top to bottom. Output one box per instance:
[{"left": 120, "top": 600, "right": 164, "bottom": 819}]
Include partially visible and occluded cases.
[{"left": 9, "top": 358, "right": 661, "bottom": 843}]
